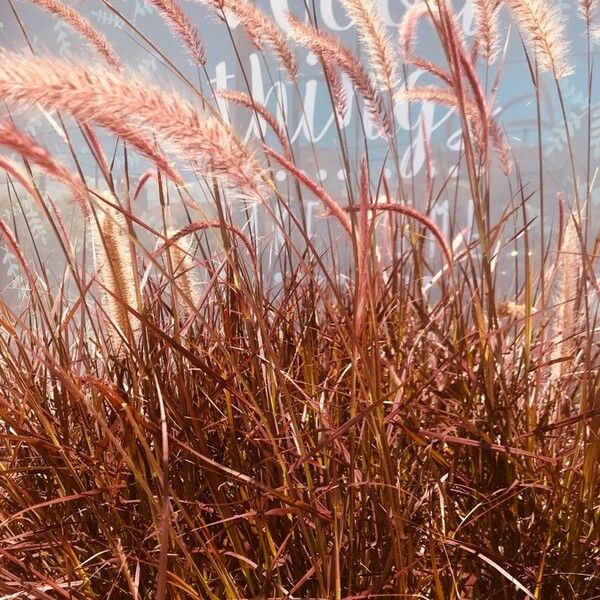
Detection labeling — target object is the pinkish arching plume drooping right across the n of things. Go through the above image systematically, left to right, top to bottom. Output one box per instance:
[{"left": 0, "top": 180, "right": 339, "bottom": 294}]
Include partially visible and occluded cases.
[{"left": 288, "top": 15, "right": 392, "bottom": 133}]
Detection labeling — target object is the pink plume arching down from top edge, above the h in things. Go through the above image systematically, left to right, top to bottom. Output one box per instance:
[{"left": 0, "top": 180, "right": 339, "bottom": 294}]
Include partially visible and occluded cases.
[{"left": 198, "top": 0, "right": 298, "bottom": 80}]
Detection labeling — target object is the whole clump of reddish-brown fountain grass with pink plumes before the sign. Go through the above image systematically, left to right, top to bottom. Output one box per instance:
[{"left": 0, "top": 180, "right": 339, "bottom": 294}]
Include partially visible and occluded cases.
[{"left": 0, "top": 0, "right": 600, "bottom": 600}]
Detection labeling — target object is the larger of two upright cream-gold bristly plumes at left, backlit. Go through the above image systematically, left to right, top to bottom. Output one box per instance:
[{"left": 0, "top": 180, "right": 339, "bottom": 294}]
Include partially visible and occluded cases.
[{"left": 92, "top": 197, "right": 141, "bottom": 337}]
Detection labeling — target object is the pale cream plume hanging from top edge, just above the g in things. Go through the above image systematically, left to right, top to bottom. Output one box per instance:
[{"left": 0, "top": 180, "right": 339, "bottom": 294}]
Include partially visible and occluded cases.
[{"left": 341, "top": 0, "right": 399, "bottom": 91}]
